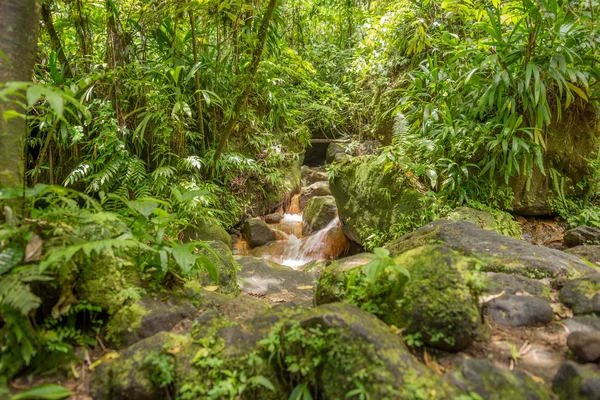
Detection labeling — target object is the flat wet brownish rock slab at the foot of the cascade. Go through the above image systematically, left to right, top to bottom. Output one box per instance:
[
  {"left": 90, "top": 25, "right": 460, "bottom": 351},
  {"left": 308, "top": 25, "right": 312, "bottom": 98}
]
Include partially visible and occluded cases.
[{"left": 236, "top": 256, "right": 316, "bottom": 304}]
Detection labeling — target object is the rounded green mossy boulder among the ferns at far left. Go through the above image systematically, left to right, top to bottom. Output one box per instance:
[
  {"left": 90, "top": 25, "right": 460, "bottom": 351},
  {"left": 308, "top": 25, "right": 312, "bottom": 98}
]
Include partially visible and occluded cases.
[{"left": 75, "top": 253, "right": 141, "bottom": 313}]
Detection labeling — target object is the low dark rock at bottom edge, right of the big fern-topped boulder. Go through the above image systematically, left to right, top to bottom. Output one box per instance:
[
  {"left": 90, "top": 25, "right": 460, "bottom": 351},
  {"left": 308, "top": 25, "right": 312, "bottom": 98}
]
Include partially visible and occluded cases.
[{"left": 446, "top": 359, "right": 551, "bottom": 400}]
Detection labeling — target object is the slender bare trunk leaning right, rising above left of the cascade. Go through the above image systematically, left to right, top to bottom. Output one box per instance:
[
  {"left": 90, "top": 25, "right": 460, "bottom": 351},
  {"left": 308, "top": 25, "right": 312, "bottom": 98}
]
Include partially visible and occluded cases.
[{"left": 212, "top": 0, "right": 277, "bottom": 173}]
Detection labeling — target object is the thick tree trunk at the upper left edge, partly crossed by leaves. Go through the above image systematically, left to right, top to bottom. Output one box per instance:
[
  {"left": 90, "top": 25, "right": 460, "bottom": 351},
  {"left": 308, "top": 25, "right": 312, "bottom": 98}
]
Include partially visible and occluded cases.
[{"left": 0, "top": 0, "right": 40, "bottom": 187}]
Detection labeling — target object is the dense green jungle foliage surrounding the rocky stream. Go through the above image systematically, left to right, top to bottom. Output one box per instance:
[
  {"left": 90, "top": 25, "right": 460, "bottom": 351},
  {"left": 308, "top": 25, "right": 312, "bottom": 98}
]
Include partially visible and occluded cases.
[{"left": 0, "top": 0, "right": 600, "bottom": 399}]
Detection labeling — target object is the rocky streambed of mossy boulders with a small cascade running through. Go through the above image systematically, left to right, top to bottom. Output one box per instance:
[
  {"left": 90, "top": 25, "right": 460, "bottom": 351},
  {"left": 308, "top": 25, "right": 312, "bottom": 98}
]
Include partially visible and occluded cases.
[{"left": 52, "top": 156, "right": 600, "bottom": 400}]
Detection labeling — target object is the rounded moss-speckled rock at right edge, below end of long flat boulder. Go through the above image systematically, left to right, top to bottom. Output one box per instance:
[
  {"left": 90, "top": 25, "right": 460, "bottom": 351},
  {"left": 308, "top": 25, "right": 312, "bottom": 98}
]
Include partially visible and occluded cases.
[{"left": 560, "top": 273, "right": 600, "bottom": 315}]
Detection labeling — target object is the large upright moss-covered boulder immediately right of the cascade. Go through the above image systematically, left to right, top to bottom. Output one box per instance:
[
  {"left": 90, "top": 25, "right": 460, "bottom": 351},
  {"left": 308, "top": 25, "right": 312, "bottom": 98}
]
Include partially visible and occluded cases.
[{"left": 330, "top": 156, "right": 425, "bottom": 245}]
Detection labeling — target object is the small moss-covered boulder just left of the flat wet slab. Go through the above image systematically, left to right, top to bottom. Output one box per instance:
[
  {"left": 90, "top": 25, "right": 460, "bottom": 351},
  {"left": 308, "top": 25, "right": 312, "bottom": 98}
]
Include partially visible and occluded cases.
[{"left": 197, "top": 241, "right": 242, "bottom": 295}]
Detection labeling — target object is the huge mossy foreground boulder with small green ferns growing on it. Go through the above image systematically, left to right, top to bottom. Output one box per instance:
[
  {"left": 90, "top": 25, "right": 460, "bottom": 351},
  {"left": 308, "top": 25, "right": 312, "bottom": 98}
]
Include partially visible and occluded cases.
[{"left": 91, "top": 303, "right": 453, "bottom": 400}]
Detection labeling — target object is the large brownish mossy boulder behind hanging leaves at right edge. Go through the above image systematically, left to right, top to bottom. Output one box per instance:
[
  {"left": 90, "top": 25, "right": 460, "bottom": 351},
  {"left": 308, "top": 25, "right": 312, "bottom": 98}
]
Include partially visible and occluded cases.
[{"left": 510, "top": 100, "right": 600, "bottom": 216}]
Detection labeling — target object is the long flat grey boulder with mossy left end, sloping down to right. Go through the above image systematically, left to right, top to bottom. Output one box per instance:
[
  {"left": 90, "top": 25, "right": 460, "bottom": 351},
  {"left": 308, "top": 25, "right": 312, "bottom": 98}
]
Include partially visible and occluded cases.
[{"left": 384, "top": 219, "right": 592, "bottom": 279}]
